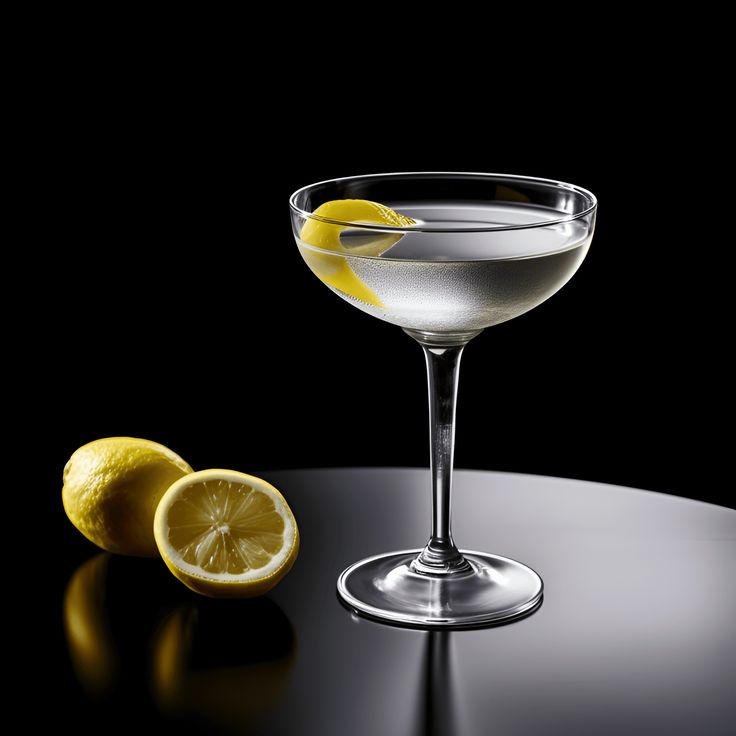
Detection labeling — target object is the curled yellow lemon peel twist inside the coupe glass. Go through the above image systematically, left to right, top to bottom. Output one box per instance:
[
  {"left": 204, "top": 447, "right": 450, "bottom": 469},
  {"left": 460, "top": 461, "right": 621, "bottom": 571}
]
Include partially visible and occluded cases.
[{"left": 301, "top": 199, "right": 416, "bottom": 308}]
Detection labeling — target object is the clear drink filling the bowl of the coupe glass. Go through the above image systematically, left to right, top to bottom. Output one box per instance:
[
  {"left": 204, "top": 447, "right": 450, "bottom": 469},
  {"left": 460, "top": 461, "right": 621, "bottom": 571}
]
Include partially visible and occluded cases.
[{"left": 298, "top": 202, "right": 591, "bottom": 332}]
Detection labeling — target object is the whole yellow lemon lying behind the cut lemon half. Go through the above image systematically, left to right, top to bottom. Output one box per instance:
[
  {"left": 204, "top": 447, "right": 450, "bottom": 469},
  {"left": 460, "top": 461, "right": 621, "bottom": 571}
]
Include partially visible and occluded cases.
[{"left": 61, "top": 437, "right": 192, "bottom": 557}]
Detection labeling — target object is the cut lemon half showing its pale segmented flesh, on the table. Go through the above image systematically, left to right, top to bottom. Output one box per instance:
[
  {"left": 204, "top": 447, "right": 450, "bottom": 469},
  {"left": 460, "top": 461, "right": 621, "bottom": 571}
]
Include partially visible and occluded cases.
[{"left": 154, "top": 469, "right": 299, "bottom": 598}]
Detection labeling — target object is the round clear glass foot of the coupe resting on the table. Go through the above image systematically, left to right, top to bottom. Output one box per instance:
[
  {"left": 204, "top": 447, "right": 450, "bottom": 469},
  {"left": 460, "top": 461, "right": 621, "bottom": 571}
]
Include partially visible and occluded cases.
[{"left": 337, "top": 549, "right": 544, "bottom": 628}]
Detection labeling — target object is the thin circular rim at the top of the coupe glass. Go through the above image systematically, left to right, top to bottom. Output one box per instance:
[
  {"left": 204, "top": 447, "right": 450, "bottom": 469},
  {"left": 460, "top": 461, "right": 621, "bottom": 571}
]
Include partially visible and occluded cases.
[{"left": 289, "top": 171, "right": 598, "bottom": 233}]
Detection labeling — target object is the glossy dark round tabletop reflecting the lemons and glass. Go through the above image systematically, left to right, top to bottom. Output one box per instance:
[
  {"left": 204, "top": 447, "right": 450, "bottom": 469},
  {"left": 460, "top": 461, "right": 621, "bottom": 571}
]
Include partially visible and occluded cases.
[{"left": 59, "top": 469, "right": 736, "bottom": 736}]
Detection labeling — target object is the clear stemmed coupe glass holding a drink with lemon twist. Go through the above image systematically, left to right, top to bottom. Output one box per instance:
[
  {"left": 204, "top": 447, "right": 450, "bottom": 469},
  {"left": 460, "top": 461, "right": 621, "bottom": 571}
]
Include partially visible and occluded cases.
[{"left": 290, "top": 172, "right": 597, "bottom": 628}]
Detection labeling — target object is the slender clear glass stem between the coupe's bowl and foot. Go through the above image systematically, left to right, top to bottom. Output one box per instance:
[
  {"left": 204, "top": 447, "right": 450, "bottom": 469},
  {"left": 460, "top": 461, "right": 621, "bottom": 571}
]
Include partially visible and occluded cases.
[{"left": 410, "top": 332, "right": 478, "bottom": 575}]
